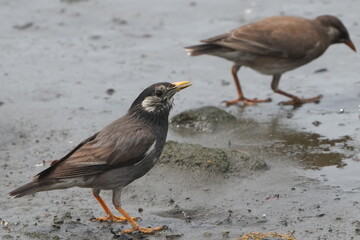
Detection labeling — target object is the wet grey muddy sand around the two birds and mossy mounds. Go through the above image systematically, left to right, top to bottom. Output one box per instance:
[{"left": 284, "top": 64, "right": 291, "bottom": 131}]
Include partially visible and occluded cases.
[{"left": 0, "top": 0, "right": 360, "bottom": 240}]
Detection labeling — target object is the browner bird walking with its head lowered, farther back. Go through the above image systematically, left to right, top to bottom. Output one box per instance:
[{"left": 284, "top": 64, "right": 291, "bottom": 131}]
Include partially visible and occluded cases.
[{"left": 185, "top": 15, "right": 356, "bottom": 106}]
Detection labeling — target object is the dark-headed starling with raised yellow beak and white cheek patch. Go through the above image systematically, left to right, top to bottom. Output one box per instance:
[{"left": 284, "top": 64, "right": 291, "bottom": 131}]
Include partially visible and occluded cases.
[{"left": 9, "top": 81, "right": 191, "bottom": 234}]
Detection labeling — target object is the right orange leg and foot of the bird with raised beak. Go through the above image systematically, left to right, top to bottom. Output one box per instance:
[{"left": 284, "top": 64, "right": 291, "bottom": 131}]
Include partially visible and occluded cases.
[{"left": 113, "top": 190, "right": 165, "bottom": 234}]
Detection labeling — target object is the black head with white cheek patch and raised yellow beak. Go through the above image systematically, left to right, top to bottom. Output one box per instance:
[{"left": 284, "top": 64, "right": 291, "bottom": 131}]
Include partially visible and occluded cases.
[{"left": 129, "top": 81, "right": 191, "bottom": 122}]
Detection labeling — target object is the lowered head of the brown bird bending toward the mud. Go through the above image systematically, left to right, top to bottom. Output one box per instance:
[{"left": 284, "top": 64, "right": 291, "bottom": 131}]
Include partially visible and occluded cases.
[{"left": 316, "top": 15, "right": 356, "bottom": 52}]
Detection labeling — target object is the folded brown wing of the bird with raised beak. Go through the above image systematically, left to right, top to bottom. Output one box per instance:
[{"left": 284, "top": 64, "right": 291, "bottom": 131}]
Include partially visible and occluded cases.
[{"left": 37, "top": 121, "right": 155, "bottom": 179}]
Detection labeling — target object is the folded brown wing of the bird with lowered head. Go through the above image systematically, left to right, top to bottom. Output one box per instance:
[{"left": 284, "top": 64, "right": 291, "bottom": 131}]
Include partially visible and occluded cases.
[{"left": 202, "top": 16, "right": 319, "bottom": 59}]
